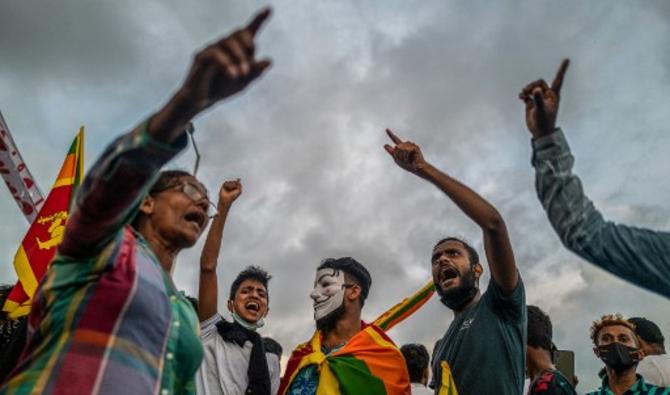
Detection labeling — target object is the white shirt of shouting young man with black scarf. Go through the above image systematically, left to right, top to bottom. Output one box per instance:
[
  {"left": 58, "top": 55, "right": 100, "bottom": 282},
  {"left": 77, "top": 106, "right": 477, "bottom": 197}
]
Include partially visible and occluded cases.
[{"left": 195, "top": 314, "right": 280, "bottom": 395}]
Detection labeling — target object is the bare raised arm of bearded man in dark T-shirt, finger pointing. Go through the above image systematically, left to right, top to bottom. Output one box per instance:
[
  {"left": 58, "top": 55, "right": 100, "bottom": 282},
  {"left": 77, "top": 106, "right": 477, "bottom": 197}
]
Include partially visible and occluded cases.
[{"left": 384, "top": 129, "right": 519, "bottom": 293}]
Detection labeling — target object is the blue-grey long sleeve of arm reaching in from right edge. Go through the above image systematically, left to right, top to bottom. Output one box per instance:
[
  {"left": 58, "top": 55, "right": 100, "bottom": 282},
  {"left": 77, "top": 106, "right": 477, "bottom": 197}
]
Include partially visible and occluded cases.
[{"left": 533, "top": 129, "right": 670, "bottom": 297}]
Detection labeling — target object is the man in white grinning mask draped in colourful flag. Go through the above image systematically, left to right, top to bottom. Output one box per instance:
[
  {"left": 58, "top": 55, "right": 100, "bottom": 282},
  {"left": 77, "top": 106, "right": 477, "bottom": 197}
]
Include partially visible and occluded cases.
[{"left": 278, "top": 257, "right": 433, "bottom": 395}]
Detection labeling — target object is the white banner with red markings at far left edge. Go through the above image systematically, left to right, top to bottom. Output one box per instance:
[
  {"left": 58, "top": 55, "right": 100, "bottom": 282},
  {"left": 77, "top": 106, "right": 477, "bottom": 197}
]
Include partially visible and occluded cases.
[{"left": 0, "top": 112, "right": 44, "bottom": 224}]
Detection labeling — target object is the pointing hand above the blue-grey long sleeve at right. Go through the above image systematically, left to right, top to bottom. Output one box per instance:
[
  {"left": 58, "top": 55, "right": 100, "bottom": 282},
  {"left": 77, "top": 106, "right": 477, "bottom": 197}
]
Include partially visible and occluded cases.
[{"left": 519, "top": 59, "right": 570, "bottom": 138}]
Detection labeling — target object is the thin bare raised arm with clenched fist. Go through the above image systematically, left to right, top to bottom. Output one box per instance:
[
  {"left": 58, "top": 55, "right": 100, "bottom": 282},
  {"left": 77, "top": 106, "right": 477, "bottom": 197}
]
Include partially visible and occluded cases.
[{"left": 198, "top": 178, "right": 242, "bottom": 321}]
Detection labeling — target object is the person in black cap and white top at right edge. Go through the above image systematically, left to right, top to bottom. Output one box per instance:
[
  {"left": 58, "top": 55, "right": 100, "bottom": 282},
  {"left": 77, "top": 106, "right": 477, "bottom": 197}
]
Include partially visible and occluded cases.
[{"left": 628, "top": 317, "right": 670, "bottom": 387}]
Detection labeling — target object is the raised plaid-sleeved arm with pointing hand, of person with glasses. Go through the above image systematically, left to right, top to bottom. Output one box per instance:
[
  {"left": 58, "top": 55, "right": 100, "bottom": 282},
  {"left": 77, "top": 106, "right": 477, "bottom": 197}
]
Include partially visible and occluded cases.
[{"left": 59, "top": 10, "right": 270, "bottom": 259}]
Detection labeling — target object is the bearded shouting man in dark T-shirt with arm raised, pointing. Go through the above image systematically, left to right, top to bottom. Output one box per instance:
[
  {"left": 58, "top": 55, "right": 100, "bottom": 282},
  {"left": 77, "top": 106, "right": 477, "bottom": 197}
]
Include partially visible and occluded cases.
[{"left": 385, "top": 129, "right": 527, "bottom": 395}]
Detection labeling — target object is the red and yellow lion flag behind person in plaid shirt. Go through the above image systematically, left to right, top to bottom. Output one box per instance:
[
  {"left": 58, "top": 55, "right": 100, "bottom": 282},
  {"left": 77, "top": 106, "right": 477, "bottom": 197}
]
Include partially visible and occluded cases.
[{"left": 3, "top": 126, "right": 84, "bottom": 318}]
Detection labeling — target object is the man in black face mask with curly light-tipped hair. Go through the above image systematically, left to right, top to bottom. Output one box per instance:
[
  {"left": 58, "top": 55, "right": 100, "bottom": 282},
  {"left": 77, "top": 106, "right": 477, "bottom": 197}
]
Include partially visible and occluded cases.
[{"left": 587, "top": 314, "right": 670, "bottom": 395}]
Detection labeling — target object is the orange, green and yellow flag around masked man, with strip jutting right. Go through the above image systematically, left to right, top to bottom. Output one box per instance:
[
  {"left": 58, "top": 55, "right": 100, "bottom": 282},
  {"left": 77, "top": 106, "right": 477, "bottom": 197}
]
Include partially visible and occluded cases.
[{"left": 278, "top": 282, "right": 433, "bottom": 395}]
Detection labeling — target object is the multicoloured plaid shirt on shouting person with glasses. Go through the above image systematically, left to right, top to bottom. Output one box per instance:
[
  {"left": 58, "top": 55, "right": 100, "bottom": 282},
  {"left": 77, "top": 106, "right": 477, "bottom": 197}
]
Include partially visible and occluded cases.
[{"left": 0, "top": 122, "right": 203, "bottom": 395}]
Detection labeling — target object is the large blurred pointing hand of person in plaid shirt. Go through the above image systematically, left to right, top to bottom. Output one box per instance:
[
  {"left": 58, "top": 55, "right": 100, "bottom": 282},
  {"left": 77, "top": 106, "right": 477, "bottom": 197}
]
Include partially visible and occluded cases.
[{"left": 177, "top": 8, "right": 271, "bottom": 117}]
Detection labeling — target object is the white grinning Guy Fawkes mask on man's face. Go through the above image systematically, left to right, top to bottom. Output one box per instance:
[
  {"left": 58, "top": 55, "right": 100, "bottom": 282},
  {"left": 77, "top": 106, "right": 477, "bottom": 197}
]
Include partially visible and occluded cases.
[{"left": 309, "top": 268, "right": 345, "bottom": 321}]
